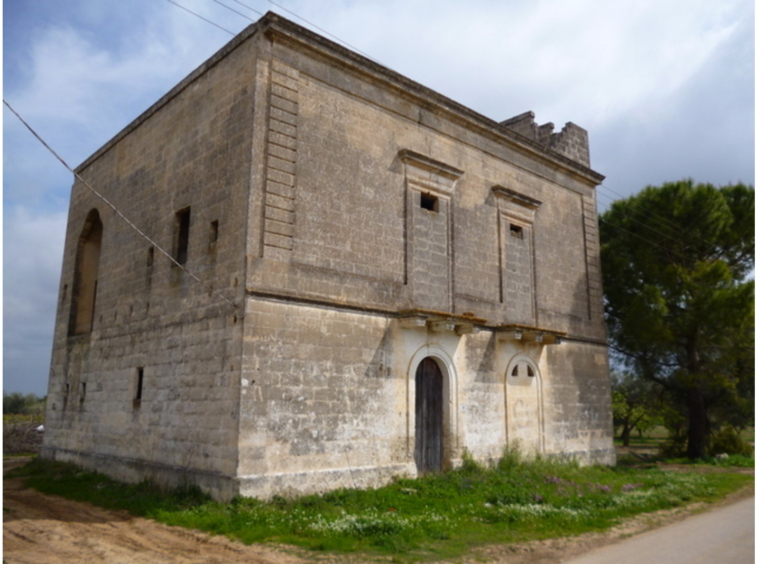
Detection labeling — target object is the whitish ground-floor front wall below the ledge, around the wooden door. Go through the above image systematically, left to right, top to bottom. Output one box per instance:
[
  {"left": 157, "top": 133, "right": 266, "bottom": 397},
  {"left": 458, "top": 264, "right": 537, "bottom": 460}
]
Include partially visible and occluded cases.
[{"left": 238, "top": 299, "right": 615, "bottom": 498}]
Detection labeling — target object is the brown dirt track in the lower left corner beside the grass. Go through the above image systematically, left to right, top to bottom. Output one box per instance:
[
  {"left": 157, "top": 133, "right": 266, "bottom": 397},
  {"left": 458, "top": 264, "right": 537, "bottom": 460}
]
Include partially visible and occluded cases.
[{"left": 3, "top": 459, "right": 300, "bottom": 564}]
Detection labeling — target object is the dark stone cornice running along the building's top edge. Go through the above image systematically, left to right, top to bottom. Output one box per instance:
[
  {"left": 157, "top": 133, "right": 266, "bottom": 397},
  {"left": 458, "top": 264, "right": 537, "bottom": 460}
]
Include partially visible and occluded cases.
[{"left": 76, "top": 11, "right": 605, "bottom": 185}]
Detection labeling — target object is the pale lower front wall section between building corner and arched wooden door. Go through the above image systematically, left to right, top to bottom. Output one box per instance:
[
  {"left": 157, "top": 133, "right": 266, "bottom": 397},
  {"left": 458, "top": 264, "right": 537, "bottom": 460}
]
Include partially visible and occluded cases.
[{"left": 238, "top": 299, "right": 411, "bottom": 497}]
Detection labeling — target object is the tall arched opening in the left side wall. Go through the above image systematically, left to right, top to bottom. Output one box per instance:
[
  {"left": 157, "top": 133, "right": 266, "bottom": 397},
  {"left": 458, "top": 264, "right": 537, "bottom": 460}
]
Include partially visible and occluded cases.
[{"left": 69, "top": 209, "right": 103, "bottom": 335}]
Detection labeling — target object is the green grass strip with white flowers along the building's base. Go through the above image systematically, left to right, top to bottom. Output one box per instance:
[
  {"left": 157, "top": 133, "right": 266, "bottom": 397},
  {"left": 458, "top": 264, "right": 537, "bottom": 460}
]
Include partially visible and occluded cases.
[{"left": 7, "top": 452, "right": 753, "bottom": 561}]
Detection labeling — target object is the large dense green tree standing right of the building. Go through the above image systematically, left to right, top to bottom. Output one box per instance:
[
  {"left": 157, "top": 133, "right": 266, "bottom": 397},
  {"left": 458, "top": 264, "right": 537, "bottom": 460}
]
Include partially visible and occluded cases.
[{"left": 600, "top": 180, "right": 755, "bottom": 459}]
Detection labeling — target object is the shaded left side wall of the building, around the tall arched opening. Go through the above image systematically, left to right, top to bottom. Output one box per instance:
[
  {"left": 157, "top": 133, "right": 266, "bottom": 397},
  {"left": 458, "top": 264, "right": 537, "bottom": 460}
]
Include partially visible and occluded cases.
[{"left": 45, "top": 30, "right": 256, "bottom": 491}]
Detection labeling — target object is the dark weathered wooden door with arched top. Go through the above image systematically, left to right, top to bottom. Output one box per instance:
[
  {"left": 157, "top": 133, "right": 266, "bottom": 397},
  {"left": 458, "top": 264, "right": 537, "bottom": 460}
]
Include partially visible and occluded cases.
[{"left": 414, "top": 357, "right": 443, "bottom": 474}]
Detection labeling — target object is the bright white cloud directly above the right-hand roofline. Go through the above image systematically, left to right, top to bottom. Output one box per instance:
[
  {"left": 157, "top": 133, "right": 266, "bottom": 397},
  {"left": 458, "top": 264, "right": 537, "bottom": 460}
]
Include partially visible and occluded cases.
[{"left": 286, "top": 0, "right": 750, "bottom": 128}]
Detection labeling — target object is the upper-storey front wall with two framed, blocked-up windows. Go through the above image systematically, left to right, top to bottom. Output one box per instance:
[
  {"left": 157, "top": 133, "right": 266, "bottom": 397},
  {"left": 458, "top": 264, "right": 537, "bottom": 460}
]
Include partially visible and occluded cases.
[{"left": 247, "top": 37, "right": 605, "bottom": 341}]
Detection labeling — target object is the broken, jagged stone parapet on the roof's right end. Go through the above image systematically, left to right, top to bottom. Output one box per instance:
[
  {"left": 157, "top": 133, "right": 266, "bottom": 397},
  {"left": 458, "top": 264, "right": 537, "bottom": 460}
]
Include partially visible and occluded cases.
[{"left": 500, "top": 112, "right": 590, "bottom": 168}]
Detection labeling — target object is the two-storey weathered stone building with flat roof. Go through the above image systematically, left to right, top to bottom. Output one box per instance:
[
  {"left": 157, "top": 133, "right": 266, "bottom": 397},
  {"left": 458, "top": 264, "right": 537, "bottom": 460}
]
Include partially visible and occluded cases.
[{"left": 43, "top": 13, "right": 615, "bottom": 498}]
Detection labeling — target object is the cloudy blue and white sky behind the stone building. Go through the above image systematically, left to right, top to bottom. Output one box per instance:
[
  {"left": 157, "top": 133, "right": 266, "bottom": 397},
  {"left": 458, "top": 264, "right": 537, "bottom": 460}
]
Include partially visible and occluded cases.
[{"left": 3, "top": 0, "right": 755, "bottom": 395}]
